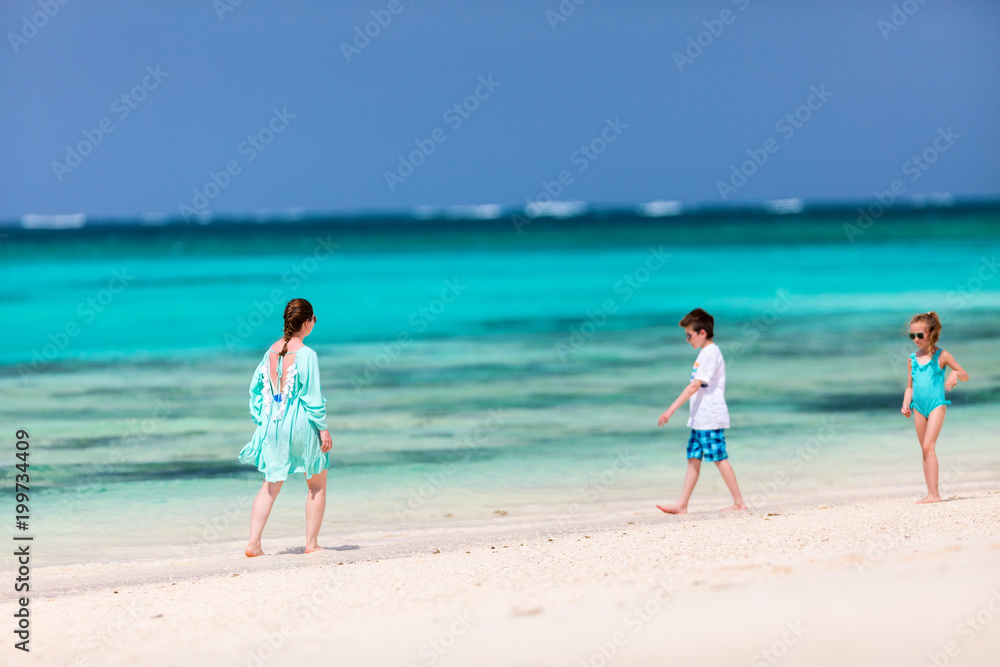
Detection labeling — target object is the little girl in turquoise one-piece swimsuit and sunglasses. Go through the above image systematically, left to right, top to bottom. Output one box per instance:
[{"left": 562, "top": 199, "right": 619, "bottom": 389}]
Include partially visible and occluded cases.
[{"left": 903, "top": 311, "right": 969, "bottom": 503}]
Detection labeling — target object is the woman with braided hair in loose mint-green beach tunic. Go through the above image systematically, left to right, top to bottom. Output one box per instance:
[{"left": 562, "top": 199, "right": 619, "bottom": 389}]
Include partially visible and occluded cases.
[{"left": 239, "top": 299, "right": 333, "bottom": 558}]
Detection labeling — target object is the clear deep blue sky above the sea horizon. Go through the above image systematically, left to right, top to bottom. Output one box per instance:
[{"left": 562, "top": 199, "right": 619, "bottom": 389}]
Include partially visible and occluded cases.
[{"left": 0, "top": 0, "right": 1000, "bottom": 219}]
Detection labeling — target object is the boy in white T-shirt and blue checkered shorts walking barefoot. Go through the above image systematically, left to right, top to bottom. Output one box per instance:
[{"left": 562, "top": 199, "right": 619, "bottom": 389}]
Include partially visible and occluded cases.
[{"left": 656, "top": 308, "right": 747, "bottom": 514}]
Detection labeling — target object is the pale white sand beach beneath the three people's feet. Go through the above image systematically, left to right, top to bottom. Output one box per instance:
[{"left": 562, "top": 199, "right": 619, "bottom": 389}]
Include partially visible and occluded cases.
[{"left": 15, "top": 481, "right": 1000, "bottom": 667}]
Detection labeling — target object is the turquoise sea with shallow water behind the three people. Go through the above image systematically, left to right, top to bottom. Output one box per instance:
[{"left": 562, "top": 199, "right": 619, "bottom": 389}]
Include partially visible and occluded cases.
[{"left": 0, "top": 204, "right": 1000, "bottom": 564}]
